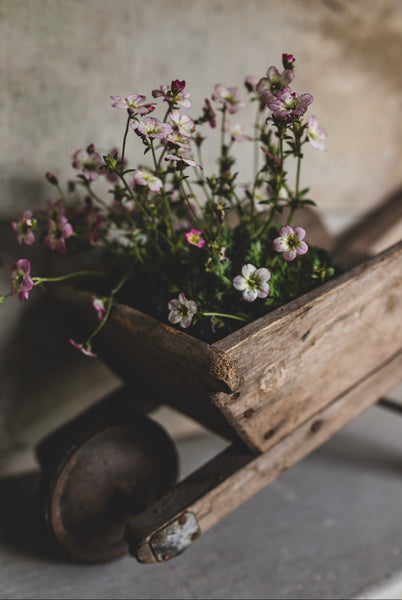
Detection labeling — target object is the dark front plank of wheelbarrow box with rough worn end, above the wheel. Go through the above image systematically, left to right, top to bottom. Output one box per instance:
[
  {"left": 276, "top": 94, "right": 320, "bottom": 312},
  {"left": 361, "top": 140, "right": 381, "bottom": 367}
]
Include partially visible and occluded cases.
[{"left": 53, "top": 287, "right": 241, "bottom": 393}]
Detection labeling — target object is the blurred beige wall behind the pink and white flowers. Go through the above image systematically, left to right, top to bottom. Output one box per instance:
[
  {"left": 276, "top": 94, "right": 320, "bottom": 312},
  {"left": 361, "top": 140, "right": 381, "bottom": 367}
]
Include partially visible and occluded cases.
[{"left": 0, "top": 0, "right": 402, "bottom": 474}]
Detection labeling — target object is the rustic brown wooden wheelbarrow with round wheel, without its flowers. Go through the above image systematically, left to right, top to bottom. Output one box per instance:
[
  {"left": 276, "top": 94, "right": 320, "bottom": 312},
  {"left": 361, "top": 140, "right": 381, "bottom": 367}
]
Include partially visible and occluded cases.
[{"left": 37, "top": 194, "right": 402, "bottom": 563}]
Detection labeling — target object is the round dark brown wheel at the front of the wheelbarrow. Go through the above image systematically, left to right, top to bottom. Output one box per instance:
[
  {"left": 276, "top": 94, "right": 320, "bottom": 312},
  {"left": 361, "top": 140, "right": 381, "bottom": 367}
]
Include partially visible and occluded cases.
[{"left": 37, "top": 409, "right": 178, "bottom": 563}]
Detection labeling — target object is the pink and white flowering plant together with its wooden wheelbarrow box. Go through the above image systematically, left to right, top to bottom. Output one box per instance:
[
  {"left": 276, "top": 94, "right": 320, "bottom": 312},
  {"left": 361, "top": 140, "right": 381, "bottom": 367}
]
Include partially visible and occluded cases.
[{"left": 2, "top": 54, "right": 401, "bottom": 562}]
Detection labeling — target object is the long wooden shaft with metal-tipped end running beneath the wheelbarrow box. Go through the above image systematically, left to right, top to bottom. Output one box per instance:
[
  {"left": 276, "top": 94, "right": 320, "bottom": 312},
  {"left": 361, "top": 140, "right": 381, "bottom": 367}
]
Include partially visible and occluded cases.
[{"left": 126, "top": 352, "right": 402, "bottom": 563}]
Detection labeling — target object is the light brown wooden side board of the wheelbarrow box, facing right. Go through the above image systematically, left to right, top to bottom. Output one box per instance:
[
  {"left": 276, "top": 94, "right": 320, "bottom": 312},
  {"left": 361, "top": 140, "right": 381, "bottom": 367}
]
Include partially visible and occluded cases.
[{"left": 214, "top": 243, "right": 402, "bottom": 451}]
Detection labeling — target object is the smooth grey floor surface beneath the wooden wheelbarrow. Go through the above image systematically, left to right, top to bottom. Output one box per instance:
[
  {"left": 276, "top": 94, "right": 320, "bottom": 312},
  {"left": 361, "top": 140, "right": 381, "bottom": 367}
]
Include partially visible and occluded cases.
[{"left": 0, "top": 392, "right": 402, "bottom": 599}]
